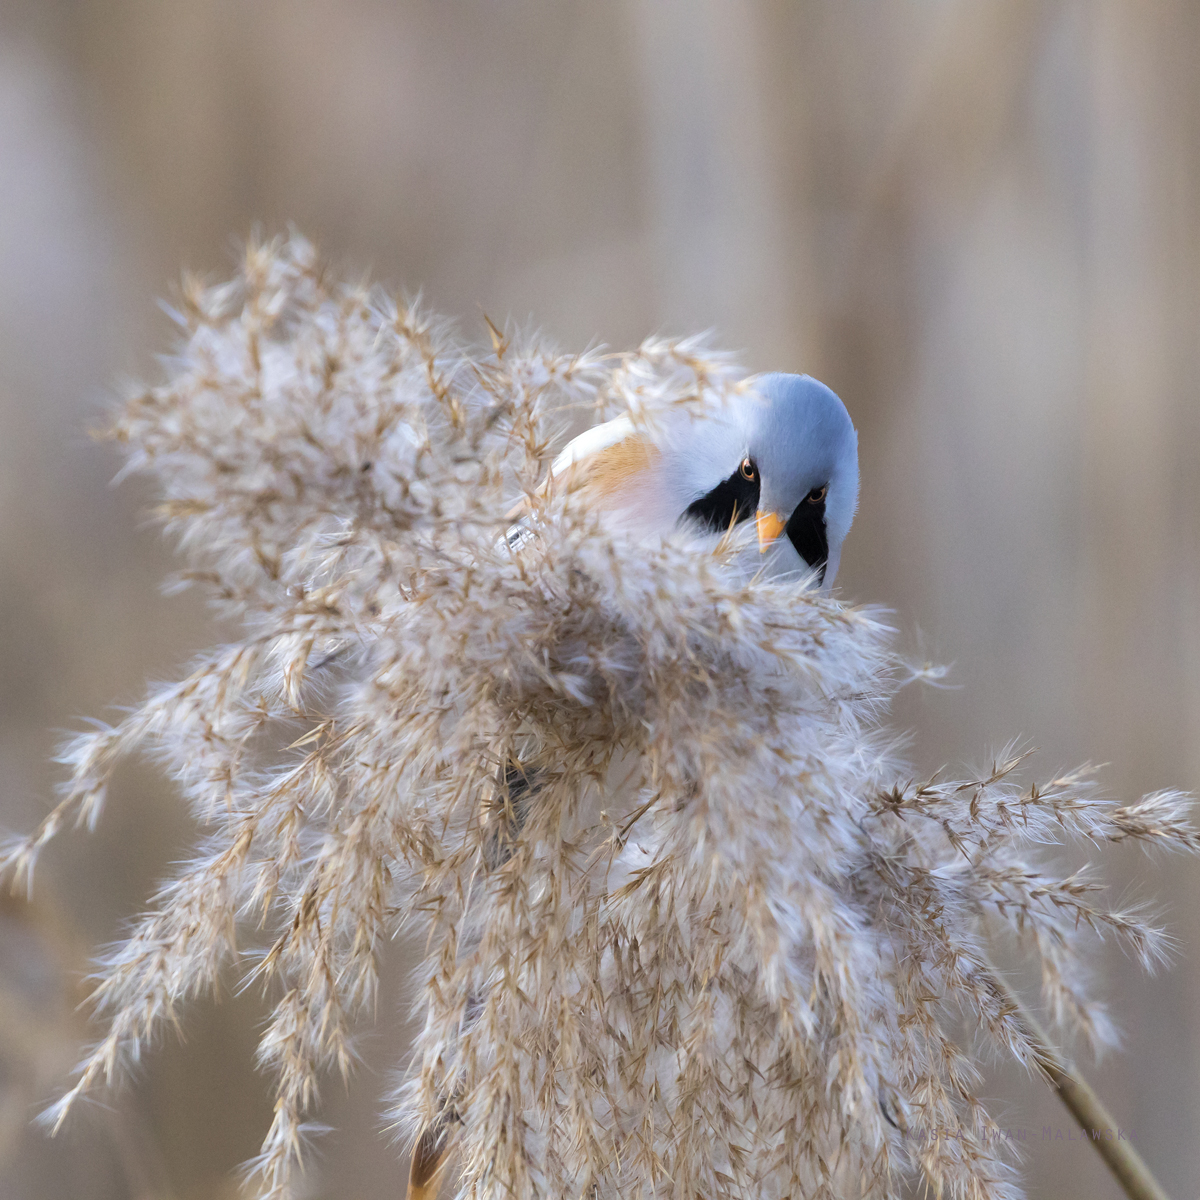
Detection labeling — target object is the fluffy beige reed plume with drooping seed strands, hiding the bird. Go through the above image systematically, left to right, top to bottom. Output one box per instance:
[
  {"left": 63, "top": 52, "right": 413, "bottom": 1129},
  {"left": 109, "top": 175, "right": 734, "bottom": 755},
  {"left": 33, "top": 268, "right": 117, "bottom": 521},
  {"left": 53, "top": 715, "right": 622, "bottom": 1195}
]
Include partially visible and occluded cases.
[{"left": 6, "top": 235, "right": 1198, "bottom": 1200}]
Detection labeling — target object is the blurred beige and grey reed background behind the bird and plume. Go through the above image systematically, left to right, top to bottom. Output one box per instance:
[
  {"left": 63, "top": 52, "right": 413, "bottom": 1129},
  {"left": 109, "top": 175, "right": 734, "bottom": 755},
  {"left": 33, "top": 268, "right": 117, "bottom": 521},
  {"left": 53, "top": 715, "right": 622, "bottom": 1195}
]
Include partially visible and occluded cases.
[{"left": 0, "top": 0, "right": 1200, "bottom": 1200}]
